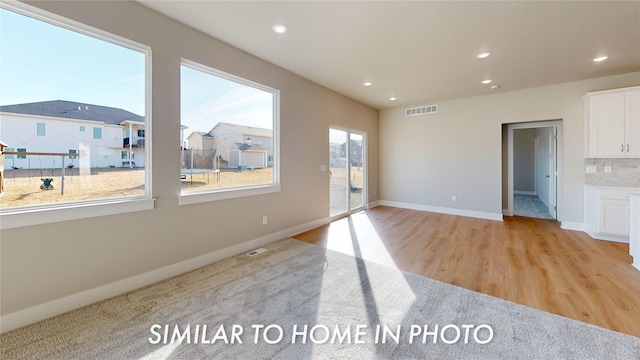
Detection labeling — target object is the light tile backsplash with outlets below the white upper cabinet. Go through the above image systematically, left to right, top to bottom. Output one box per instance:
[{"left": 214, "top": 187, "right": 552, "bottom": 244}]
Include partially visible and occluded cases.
[{"left": 584, "top": 159, "right": 640, "bottom": 187}]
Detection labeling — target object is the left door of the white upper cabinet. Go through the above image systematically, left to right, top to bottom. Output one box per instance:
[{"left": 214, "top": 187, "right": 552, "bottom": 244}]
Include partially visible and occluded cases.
[{"left": 589, "top": 93, "right": 626, "bottom": 157}]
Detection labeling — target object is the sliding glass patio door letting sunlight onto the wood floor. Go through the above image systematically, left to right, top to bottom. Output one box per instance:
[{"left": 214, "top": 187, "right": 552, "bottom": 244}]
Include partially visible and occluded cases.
[{"left": 329, "top": 128, "right": 367, "bottom": 217}]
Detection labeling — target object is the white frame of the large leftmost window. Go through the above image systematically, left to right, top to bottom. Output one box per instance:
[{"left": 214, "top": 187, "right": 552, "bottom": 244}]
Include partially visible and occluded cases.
[{"left": 0, "top": 1, "right": 155, "bottom": 230}]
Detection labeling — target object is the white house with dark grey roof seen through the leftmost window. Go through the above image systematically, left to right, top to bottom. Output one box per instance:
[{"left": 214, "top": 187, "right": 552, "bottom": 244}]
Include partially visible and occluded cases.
[{"left": 0, "top": 100, "right": 145, "bottom": 169}]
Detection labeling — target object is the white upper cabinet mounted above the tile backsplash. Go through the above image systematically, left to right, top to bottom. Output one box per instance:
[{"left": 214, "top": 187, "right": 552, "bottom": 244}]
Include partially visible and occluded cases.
[{"left": 584, "top": 86, "right": 640, "bottom": 158}]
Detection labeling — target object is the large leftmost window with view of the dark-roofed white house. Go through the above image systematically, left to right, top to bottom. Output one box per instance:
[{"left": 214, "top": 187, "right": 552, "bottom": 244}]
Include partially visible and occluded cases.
[{"left": 0, "top": 2, "right": 153, "bottom": 229}]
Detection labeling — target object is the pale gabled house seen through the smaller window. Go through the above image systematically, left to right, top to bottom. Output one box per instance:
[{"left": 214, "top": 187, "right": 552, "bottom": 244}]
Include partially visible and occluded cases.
[{"left": 187, "top": 122, "right": 273, "bottom": 168}]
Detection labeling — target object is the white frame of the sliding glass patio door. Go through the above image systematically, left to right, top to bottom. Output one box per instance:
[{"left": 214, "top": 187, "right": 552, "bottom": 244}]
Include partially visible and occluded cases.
[{"left": 327, "top": 125, "right": 369, "bottom": 220}]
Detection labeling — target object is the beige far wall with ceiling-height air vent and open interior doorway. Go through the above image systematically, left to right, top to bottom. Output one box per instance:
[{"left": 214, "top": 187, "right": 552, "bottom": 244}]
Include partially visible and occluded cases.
[{"left": 380, "top": 73, "right": 640, "bottom": 224}]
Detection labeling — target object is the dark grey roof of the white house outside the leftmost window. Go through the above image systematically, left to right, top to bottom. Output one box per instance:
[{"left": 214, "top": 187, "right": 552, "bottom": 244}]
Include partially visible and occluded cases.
[{"left": 0, "top": 100, "right": 144, "bottom": 125}]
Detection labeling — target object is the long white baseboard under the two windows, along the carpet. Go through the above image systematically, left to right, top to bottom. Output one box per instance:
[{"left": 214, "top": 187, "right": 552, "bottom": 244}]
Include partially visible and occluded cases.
[{"left": 0, "top": 217, "right": 330, "bottom": 334}]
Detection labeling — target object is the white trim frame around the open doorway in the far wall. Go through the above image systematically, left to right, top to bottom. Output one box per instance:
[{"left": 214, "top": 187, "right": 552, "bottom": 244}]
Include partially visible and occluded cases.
[{"left": 504, "top": 120, "right": 564, "bottom": 221}]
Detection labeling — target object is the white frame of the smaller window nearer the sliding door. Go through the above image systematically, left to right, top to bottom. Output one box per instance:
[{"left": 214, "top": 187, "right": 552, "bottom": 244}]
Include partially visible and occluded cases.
[{"left": 178, "top": 58, "right": 282, "bottom": 206}]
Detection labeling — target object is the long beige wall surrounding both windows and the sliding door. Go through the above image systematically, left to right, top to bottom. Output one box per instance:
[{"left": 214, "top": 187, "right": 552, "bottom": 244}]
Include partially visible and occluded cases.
[{"left": 0, "top": 1, "right": 379, "bottom": 324}]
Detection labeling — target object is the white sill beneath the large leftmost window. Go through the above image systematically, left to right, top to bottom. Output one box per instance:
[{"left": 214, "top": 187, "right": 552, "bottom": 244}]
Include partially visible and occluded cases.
[{"left": 0, "top": 198, "right": 155, "bottom": 230}]
